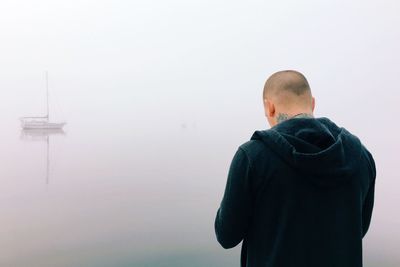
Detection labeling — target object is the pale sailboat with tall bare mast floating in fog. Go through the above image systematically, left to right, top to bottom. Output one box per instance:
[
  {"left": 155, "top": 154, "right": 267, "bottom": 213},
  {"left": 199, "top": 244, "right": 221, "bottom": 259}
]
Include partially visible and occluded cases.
[{"left": 20, "top": 71, "right": 66, "bottom": 130}]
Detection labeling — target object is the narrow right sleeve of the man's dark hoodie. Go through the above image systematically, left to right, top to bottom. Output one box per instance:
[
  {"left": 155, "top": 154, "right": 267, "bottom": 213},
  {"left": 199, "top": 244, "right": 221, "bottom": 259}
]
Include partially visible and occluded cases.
[{"left": 362, "top": 150, "right": 376, "bottom": 240}]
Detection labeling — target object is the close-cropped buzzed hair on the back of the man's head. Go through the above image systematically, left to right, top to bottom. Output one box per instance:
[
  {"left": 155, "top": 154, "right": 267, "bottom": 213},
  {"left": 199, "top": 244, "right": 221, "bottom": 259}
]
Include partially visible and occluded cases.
[{"left": 263, "top": 70, "right": 311, "bottom": 108}]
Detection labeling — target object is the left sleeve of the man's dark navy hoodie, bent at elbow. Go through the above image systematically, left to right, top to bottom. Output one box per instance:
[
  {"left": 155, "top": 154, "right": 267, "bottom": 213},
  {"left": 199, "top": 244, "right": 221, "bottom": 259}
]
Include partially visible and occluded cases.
[{"left": 214, "top": 147, "right": 252, "bottom": 249}]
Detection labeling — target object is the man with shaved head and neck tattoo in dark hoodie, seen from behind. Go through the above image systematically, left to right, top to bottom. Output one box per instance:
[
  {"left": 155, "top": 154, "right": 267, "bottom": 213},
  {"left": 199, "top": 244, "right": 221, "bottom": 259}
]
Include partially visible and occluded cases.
[{"left": 214, "top": 70, "right": 376, "bottom": 267}]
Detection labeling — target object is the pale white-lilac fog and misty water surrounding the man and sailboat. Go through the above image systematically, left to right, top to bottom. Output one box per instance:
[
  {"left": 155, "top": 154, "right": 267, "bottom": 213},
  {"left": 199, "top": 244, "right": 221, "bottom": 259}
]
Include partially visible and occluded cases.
[{"left": 0, "top": 0, "right": 400, "bottom": 267}]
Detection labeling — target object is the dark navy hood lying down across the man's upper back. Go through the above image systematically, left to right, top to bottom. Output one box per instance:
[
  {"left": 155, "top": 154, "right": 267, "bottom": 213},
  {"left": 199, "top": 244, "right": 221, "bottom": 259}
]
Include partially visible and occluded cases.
[{"left": 251, "top": 117, "right": 362, "bottom": 185}]
